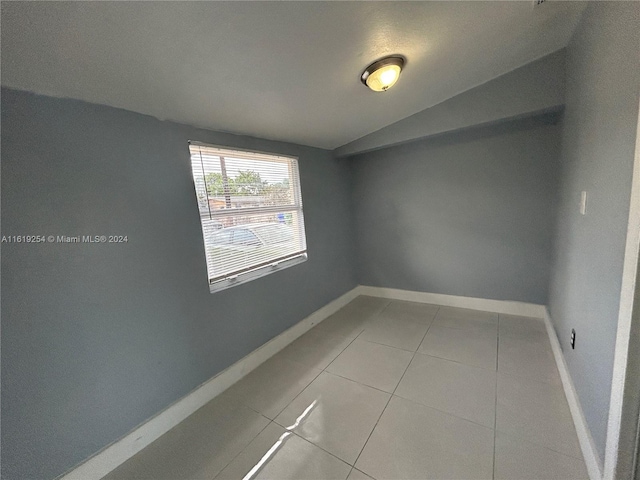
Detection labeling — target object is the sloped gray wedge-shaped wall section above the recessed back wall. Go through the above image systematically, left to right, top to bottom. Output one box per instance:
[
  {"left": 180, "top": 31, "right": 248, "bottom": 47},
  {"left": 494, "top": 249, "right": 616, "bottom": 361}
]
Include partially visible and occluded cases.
[{"left": 334, "top": 49, "right": 565, "bottom": 156}]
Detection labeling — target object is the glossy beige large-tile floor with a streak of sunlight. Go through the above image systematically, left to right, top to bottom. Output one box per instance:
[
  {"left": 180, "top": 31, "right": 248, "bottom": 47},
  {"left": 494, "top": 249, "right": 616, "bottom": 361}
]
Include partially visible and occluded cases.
[{"left": 105, "top": 296, "right": 588, "bottom": 480}]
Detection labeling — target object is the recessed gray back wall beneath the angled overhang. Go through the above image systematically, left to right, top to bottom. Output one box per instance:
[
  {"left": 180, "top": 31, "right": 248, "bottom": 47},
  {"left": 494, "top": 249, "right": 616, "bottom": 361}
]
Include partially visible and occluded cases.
[{"left": 353, "top": 114, "right": 560, "bottom": 304}]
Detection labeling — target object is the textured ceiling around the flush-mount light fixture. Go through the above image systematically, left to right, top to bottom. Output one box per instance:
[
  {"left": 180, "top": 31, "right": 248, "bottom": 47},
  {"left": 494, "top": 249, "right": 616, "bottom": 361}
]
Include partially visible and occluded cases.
[{"left": 1, "top": 0, "right": 584, "bottom": 148}]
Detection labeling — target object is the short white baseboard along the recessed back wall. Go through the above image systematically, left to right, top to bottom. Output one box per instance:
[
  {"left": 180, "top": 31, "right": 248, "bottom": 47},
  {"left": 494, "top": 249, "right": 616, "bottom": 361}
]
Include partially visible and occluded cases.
[{"left": 358, "top": 285, "right": 546, "bottom": 318}]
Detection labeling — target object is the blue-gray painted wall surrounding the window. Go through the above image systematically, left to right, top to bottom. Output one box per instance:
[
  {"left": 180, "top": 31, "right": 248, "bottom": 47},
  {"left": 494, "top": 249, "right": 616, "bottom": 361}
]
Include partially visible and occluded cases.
[{"left": 2, "top": 89, "right": 356, "bottom": 479}]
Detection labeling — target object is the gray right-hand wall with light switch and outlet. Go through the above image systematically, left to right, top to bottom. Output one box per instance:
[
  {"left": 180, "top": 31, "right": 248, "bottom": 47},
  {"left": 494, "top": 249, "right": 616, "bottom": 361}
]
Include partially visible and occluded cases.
[{"left": 549, "top": 2, "right": 640, "bottom": 459}]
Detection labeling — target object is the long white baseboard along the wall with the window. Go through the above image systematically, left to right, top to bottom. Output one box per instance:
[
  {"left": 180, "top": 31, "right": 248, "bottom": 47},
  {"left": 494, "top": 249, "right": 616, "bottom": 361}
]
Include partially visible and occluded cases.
[{"left": 61, "top": 287, "right": 359, "bottom": 480}]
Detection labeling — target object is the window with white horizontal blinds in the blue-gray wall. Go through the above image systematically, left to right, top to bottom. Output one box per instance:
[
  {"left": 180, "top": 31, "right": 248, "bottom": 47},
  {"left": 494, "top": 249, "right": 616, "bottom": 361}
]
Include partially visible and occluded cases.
[{"left": 189, "top": 142, "right": 307, "bottom": 292}]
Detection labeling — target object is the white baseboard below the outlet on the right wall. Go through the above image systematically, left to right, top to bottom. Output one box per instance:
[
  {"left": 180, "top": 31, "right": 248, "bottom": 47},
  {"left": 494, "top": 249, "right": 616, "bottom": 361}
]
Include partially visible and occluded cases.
[{"left": 544, "top": 308, "right": 602, "bottom": 480}]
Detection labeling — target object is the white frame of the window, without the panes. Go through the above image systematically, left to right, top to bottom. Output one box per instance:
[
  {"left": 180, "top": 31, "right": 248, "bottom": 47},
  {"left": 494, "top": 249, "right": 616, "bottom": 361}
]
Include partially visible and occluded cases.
[{"left": 189, "top": 140, "right": 308, "bottom": 293}]
